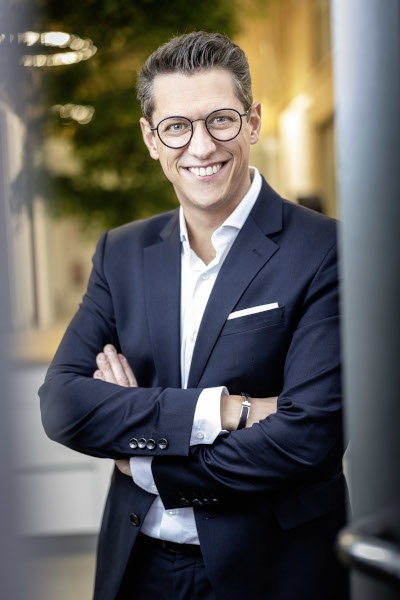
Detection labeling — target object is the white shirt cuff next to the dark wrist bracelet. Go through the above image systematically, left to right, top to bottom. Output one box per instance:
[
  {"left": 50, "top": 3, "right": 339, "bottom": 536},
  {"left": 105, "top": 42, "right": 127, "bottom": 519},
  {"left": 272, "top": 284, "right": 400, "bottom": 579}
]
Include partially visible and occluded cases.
[{"left": 190, "top": 386, "right": 228, "bottom": 446}]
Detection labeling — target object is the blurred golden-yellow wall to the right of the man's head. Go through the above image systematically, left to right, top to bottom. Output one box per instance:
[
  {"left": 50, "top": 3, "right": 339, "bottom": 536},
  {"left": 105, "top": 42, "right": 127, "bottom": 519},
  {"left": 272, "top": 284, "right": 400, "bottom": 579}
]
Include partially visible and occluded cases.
[{"left": 238, "top": 0, "right": 337, "bottom": 216}]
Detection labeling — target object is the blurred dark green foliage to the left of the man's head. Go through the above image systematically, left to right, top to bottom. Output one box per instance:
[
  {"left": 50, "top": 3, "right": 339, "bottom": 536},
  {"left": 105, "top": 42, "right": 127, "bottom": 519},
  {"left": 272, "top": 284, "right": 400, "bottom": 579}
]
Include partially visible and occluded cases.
[{"left": 32, "top": 0, "right": 238, "bottom": 227}]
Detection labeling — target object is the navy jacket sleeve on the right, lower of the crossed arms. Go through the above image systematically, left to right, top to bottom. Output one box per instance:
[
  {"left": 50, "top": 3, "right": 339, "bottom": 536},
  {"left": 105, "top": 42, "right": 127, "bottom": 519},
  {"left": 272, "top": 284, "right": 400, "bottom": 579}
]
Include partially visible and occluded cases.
[{"left": 152, "top": 245, "right": 342, "bottom": 508}]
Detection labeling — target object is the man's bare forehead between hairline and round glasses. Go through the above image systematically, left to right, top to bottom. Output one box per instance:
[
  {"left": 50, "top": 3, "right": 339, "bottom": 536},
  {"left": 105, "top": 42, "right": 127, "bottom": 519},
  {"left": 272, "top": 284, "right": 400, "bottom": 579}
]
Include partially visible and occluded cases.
[{"left": 153, "top": 69, "right": 239, "bottom": 121}]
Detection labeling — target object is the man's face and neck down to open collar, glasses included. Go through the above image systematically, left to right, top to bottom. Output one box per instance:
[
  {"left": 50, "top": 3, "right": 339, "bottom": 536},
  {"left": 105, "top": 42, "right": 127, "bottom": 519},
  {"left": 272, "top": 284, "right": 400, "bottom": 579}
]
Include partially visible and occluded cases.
[{"left": 141, "top": 67, "right": 261, "bottom": 260}]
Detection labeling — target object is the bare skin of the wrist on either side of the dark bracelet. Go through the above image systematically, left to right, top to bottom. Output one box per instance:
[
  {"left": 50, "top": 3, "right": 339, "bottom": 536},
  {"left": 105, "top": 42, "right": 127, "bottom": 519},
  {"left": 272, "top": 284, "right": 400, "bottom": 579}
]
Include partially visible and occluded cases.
[{"left": 221, "top": 396, "right": 278, "bottom": 431}]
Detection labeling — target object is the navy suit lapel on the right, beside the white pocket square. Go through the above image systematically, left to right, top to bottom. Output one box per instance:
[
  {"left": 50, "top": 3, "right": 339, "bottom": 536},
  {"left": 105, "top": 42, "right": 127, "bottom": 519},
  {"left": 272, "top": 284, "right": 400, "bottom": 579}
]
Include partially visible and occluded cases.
[{"left": 188, "top": 181, "right": 282, "bottom": 388}]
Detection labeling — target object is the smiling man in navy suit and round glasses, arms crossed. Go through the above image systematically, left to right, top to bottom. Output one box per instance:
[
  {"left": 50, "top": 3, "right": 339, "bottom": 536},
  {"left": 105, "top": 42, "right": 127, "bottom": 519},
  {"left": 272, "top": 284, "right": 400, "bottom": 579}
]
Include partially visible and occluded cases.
[{"left": 41, "top": 32, "right": 346, "bottom": 600}]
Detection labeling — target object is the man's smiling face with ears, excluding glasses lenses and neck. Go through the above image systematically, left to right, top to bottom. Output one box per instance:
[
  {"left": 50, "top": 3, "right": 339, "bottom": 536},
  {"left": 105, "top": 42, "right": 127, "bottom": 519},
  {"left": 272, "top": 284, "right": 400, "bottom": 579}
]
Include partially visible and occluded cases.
[{"left": 141, "top": 69, "right": 261, "bottom": 222}]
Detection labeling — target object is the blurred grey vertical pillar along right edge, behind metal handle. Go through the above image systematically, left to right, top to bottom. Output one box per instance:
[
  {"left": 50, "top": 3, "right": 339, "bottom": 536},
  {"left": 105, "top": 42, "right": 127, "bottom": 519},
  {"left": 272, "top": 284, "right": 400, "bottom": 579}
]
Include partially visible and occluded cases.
[{"left": 332, "top": 0, "right": 400, "bottom": 600}]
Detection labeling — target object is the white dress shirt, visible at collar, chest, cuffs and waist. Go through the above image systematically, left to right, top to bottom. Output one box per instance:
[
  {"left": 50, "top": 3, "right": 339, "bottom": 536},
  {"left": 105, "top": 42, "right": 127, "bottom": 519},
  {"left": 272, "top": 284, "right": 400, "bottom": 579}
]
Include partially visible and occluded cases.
[{"left": 130, "top": 167, "right": 261, "bottom": 544}]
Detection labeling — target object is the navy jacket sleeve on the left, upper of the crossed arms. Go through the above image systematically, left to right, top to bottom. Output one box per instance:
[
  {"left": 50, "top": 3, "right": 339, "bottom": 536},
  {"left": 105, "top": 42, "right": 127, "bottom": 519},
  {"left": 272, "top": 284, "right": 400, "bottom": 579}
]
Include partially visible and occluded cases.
[{"left": 39, "top": 233, "right": 201, "bottom": 458}]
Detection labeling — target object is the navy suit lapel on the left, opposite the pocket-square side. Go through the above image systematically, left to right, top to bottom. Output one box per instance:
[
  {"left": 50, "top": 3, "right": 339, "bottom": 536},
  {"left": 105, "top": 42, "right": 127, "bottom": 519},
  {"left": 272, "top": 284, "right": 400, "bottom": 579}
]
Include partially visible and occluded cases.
[{"left": 144, "top": 211, "right": 181, "bottom": 388}]
